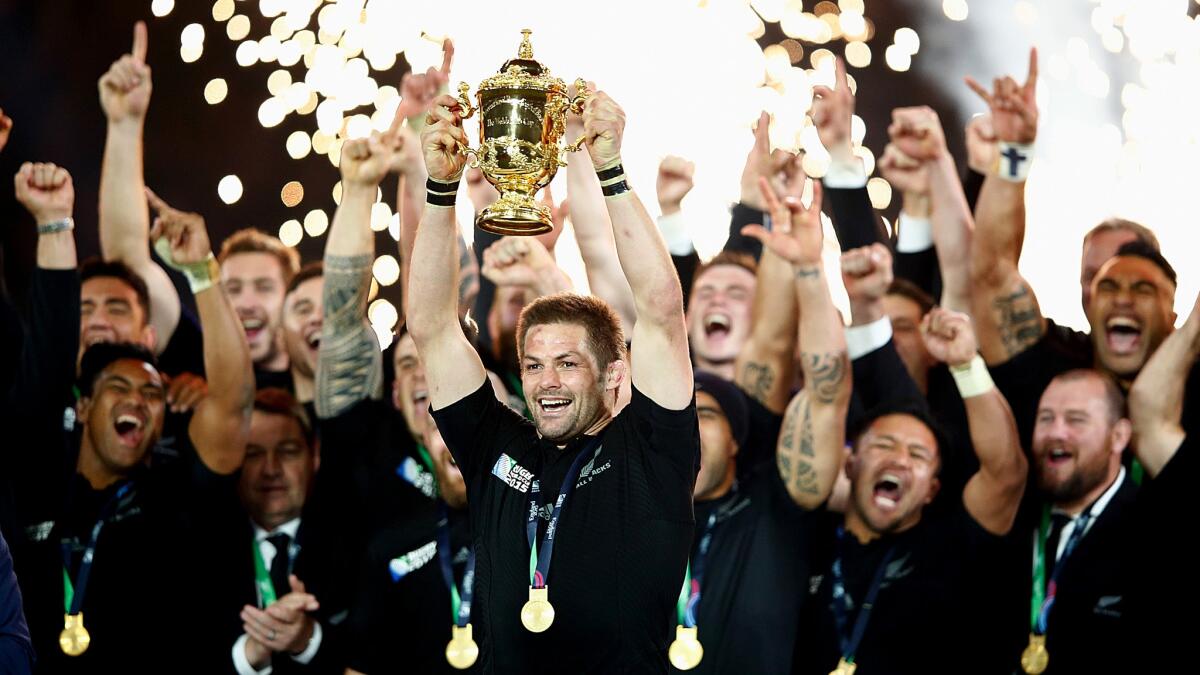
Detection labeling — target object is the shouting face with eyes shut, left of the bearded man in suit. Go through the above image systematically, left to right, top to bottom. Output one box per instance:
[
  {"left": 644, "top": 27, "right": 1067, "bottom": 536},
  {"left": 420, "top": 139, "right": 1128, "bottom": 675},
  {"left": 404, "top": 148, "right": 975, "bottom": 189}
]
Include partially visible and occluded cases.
[{"left": 846, "top": 414, "right": 940, "bottom": 534}]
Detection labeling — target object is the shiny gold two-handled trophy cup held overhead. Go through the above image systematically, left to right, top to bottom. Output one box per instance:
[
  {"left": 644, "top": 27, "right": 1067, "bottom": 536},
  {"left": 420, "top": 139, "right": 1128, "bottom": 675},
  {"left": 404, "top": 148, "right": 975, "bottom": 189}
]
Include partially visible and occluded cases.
[{"left": 458, "top": 29, "right": 588, "bottom": 234}]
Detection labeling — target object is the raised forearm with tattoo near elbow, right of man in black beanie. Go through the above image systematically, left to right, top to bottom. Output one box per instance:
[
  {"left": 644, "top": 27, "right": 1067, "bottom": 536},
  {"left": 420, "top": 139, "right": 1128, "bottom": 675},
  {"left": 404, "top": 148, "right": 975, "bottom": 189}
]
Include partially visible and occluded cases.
[{"left": 736, "top": 249, "right": 799, "bottom": 413}]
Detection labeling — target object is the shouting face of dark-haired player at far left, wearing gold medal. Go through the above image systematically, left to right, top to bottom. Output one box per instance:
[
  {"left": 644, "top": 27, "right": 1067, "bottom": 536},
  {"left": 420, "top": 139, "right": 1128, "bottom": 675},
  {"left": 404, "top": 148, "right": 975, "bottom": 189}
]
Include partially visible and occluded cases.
[{"left": 79, "top": 359, "right": 166, "bottom": 476}]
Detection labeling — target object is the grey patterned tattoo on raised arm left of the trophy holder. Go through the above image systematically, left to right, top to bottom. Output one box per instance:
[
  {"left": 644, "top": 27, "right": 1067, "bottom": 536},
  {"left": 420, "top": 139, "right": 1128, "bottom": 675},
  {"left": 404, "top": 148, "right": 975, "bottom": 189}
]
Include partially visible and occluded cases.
[{"left": 313, "top": 255, "right": 383, "bottom": 419}]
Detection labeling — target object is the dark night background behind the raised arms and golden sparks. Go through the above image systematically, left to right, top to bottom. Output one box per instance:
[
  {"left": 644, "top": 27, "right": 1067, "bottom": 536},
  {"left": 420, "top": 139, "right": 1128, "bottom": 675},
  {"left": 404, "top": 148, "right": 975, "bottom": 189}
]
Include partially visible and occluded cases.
[{"left": 0, "top": 0, "right": 964, "bottom": 303}]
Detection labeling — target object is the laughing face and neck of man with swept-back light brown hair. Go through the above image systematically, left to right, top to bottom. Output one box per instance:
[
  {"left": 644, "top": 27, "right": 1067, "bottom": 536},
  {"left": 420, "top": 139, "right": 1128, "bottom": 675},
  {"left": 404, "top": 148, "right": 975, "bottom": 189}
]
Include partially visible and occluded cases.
[{"left": 221, "top": 251, "right": 287, "bottom": 370}]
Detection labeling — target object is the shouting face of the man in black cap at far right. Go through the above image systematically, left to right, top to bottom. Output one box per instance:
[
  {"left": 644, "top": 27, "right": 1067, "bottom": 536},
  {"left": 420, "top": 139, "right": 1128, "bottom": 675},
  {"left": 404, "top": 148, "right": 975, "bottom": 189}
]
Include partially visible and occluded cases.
[{"left": 1087, "top": 256, "right": 1175, "bottom": 380}]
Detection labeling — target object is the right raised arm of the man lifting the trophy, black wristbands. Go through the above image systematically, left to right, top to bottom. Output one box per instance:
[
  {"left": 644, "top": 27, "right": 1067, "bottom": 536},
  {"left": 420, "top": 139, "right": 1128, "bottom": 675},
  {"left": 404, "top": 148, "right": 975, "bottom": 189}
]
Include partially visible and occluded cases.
[{"left": 571, "top": 91, "right": 695, "bottom": 410}]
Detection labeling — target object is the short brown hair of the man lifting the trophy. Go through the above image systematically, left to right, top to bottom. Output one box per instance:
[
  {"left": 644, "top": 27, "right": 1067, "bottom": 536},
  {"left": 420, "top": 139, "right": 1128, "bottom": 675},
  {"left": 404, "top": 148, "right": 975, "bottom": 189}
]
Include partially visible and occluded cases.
[{"left": 517, "top": 293, "right": 625, "bottom": 369}]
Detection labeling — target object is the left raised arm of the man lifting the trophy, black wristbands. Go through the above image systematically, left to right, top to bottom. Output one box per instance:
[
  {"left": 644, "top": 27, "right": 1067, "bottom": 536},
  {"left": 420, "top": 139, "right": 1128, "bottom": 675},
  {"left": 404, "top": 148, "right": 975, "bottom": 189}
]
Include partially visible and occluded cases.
[{"left": 406, "top": 96, "right": 487, "bottom": 410}]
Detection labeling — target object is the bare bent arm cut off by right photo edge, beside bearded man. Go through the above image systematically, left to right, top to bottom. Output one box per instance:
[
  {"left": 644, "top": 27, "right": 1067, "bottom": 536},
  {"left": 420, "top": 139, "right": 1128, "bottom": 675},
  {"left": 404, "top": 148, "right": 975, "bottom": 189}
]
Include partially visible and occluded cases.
[{"left": 1129, "top": 291, "right": 1200, "bottom": 478}]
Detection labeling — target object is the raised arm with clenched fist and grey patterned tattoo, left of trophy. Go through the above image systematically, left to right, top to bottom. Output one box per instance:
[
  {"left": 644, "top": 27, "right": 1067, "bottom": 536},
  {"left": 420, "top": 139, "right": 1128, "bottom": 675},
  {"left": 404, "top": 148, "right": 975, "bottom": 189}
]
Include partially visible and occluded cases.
[{"left": 314, "top": 129, "right": 400, "bottom": 419}]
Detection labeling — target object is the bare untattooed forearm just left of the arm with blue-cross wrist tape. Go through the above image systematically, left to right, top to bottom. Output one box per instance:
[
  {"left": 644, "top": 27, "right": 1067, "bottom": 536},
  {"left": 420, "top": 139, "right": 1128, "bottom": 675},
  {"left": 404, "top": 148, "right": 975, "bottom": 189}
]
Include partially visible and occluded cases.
[{"left": 929, "top": 154, "right": 974, "bottom": 312}]
